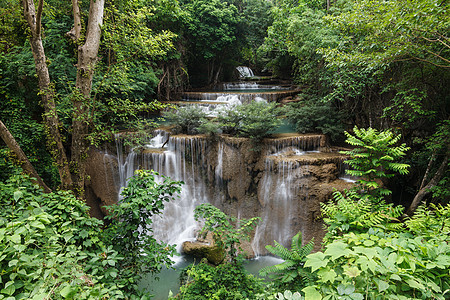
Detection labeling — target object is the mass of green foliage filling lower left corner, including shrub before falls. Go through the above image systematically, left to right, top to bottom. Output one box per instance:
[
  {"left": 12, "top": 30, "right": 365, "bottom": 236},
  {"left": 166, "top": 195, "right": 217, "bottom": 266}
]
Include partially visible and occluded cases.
[{"left": 0, "top": 172, "right": 185, "bottom": 300}]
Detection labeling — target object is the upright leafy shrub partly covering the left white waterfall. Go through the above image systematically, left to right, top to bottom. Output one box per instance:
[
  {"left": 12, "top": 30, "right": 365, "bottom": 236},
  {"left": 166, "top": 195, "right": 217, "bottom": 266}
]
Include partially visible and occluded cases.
[{"left": 104, "top": 170, "right": 182, "bottom": 274}]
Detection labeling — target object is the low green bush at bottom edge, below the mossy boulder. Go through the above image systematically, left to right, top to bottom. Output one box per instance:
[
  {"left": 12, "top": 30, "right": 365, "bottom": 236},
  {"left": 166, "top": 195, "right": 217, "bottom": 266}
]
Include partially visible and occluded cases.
[{"left": 175, "top": 262, "right": 264, "bottom": 300}]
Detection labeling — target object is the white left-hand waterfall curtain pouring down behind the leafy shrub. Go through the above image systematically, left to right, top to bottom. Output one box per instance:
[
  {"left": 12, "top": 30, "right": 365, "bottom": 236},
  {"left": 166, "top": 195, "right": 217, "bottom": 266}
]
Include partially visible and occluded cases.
[{"left": 116, "top": 131, "right": 214, "bottom": 252}]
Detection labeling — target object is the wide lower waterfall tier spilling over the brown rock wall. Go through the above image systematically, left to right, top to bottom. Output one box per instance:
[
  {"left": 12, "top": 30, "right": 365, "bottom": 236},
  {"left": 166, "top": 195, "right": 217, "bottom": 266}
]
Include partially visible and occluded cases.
[{"left": 110, "top": 131, "right": 352, "bottom": 255}]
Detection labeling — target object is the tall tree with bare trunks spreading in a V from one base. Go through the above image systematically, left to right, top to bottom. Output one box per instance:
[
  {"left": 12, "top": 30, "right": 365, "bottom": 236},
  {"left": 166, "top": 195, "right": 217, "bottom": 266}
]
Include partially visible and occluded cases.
[{"left": 22, "top": 0, "right": 105, "bottom": 197}]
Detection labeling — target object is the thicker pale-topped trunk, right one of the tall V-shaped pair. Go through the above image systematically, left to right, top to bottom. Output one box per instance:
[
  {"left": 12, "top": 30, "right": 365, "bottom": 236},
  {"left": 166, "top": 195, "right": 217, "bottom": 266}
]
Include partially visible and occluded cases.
[{"left": 71, "top": 0, "right": 105, "bottom": 197}]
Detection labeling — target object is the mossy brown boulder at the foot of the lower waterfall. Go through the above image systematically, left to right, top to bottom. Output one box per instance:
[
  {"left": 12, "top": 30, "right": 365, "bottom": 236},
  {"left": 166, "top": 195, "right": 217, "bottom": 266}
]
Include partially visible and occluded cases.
[{"left": 182, "top": 233, "right": 225, "bottom": 266}]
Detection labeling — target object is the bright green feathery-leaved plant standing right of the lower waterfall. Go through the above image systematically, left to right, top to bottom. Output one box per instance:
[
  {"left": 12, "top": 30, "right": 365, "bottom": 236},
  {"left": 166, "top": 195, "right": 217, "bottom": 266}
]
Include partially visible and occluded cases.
[{"left": 341, "top": 126, "right": 410, "bottom": 200}]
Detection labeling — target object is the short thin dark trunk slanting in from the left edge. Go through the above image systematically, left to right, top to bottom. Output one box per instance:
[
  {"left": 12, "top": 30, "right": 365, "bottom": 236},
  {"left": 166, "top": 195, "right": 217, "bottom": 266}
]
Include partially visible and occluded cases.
[{"left": 0, "top": 121, "right": 52, "bottom": 193}]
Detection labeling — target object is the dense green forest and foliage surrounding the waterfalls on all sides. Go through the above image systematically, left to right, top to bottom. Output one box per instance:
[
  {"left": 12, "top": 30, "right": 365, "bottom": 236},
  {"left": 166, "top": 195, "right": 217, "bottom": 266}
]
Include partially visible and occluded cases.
[{"left": 0, "top": 0, "right": 450, "bottom": 299}]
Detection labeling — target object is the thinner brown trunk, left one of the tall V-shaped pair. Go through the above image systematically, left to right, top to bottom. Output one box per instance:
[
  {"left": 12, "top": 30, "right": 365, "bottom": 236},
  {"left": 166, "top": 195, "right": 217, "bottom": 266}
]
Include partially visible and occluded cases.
[{"left": 22, "top": 0, "right": 72, "bottom": 189}]
